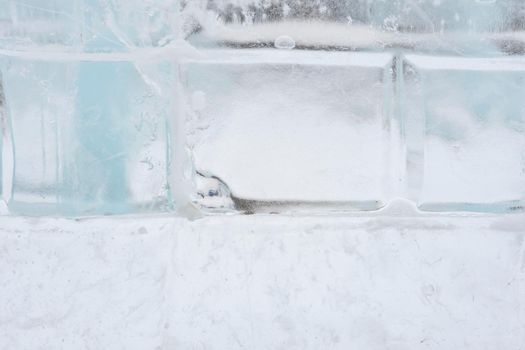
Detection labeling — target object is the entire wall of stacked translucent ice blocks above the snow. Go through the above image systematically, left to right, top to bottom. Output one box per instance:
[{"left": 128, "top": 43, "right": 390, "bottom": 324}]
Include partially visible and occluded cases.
[{"left": 0, "top": 0, "right": 525, "bottom": 216}]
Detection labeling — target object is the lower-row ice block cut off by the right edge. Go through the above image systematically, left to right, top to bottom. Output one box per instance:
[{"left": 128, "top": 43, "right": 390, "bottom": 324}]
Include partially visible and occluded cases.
[{"left": 403, "top": 55, "right": 525, "bottom": 212}]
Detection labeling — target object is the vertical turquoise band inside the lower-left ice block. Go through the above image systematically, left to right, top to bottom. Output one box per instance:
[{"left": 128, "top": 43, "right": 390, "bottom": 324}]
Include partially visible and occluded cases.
[{"left": 63, "top": 62, "right": 133, "bottom": 213}]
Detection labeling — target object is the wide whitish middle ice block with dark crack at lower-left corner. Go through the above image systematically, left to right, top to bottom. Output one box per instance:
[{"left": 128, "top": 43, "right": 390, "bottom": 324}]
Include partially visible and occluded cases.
[{"left": 182, "top": 49, "right": 394, "bottom": 213}]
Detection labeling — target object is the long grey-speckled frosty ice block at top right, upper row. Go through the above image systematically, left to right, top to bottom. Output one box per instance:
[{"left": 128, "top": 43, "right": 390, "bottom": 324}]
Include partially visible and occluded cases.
[{"left": 181, "top": 0, "right": 525, "bottom": 55}]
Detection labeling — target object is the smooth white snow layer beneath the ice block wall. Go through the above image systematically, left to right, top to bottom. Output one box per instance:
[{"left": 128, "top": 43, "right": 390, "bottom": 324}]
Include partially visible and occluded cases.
[{"left": 0, "top": 215, "right": 525, "bottom": 350}]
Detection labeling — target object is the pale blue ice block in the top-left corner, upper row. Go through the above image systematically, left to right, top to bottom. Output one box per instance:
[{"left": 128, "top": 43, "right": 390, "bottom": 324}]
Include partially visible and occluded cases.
[{"left": 0, "top": 0, "right": 179, "bottom": 52}]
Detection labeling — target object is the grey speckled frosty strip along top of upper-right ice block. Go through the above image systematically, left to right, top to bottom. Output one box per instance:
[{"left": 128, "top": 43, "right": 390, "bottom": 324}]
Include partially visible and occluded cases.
[{"left": 182, "top": 0, "right": 525, "bottom": 32}]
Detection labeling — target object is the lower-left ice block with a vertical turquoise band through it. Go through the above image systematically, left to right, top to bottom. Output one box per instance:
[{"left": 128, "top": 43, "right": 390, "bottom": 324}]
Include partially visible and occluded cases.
[{"left": 1, "top": 53, "right": 174, "bottom": 216}]
